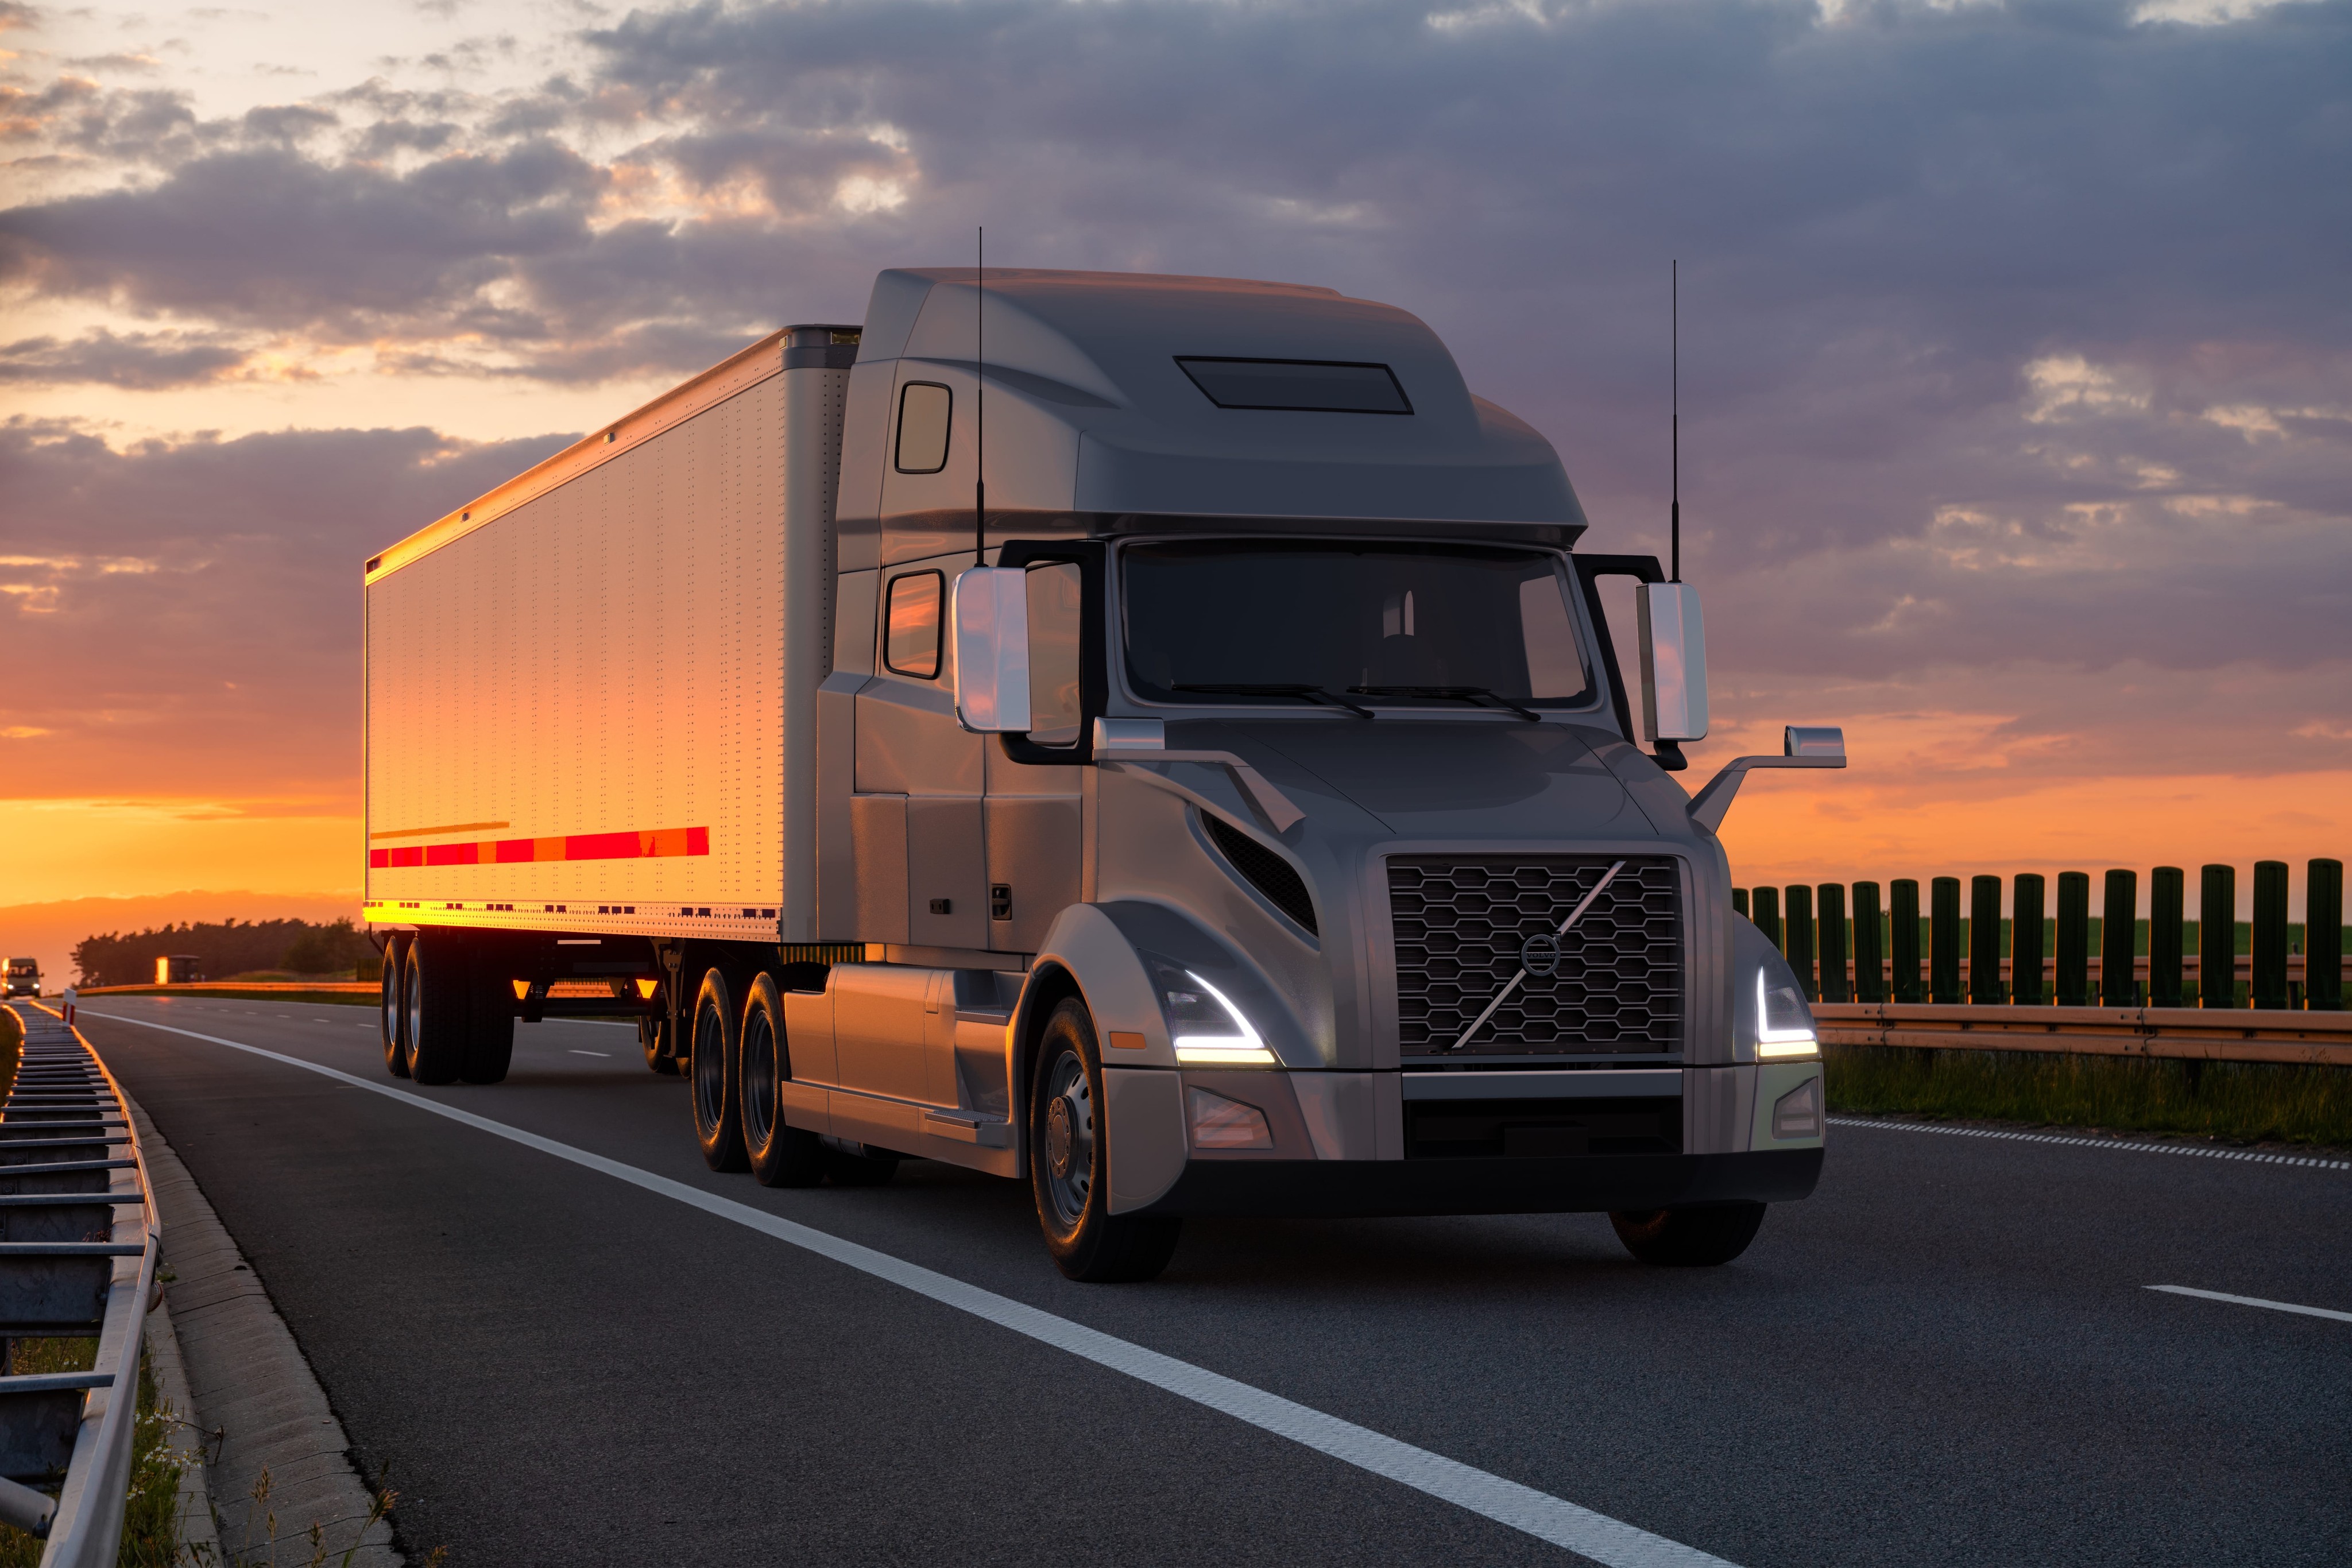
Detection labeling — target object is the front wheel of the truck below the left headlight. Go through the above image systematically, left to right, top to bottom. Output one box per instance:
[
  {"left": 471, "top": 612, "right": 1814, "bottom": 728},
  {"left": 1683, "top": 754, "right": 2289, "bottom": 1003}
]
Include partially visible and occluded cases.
[{"left": 1028, "top": 997, "right": 1183, "bottom": 1284}]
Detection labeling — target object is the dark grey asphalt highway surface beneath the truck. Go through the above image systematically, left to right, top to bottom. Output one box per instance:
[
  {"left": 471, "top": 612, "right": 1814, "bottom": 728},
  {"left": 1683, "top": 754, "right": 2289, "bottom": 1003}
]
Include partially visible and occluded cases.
[{"left": 68, "top": 997, "right": 2352, "bottom": 1568}]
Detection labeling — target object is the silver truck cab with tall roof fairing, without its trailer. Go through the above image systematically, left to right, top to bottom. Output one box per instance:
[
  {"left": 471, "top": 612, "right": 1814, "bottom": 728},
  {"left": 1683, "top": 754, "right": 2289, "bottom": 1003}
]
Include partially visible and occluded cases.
[{"left": 809, "top": 270, "right": 1842, "bottom": 1279}]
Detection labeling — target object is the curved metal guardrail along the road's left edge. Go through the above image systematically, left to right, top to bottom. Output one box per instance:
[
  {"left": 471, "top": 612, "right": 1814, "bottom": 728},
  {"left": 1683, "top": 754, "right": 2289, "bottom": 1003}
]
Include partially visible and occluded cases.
[{"left": 0, "top": 1006, "right": 163, "bottom": 1568}]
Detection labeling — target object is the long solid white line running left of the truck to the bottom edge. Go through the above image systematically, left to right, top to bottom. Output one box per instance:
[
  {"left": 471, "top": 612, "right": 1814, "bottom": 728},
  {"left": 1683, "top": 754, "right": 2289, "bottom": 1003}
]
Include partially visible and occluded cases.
[{"left": 84, "top": 1009, "right": 1731, "bottom": 1568}]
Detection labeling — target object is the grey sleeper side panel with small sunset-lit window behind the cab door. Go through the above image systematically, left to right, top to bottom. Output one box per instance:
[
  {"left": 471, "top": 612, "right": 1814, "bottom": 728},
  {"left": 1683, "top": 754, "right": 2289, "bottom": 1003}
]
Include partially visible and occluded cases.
[{"left": 844, "top": 557, "right": 988, "bottom": 959}]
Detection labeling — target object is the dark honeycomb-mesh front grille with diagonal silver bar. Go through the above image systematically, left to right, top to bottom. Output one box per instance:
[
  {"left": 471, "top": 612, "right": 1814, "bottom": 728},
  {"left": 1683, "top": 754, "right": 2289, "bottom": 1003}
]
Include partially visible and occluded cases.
[{"left": 1388, "top": 855, "right": 1682, "bottom": 1055}]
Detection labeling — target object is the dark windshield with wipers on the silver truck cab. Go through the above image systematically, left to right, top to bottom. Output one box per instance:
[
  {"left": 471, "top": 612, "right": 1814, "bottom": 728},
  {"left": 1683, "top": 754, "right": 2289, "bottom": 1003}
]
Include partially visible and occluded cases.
[{"left": 1120, "top": 539, "right": 1592, "bottom": 707}]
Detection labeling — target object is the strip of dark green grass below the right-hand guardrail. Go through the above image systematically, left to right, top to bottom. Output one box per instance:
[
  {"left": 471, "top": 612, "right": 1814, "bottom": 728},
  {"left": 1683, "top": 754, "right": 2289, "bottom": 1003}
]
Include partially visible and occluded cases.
[{"left": 1825, "top": 1046, "right": 2352, "bottom": 1147}]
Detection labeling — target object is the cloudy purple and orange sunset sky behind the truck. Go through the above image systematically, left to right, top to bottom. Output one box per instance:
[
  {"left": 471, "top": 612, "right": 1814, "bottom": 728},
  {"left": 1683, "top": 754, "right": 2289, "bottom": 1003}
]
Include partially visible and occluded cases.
[{"left": 0, "top": 0, "right": 2352, "bottom": 982}]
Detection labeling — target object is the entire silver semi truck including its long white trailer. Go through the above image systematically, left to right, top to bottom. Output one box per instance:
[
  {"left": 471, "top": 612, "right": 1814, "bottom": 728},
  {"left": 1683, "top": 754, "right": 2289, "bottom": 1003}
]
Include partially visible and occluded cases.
[{"left": 365, "top": 268, "right": 1844, "bottom": 1281}]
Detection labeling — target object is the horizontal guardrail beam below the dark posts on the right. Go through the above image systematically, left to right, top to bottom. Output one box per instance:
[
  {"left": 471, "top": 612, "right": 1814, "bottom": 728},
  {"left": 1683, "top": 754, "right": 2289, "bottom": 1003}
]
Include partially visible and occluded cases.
[{"left": 1813, "top": 1001, "right": 2352, "bottom": 1067}]
